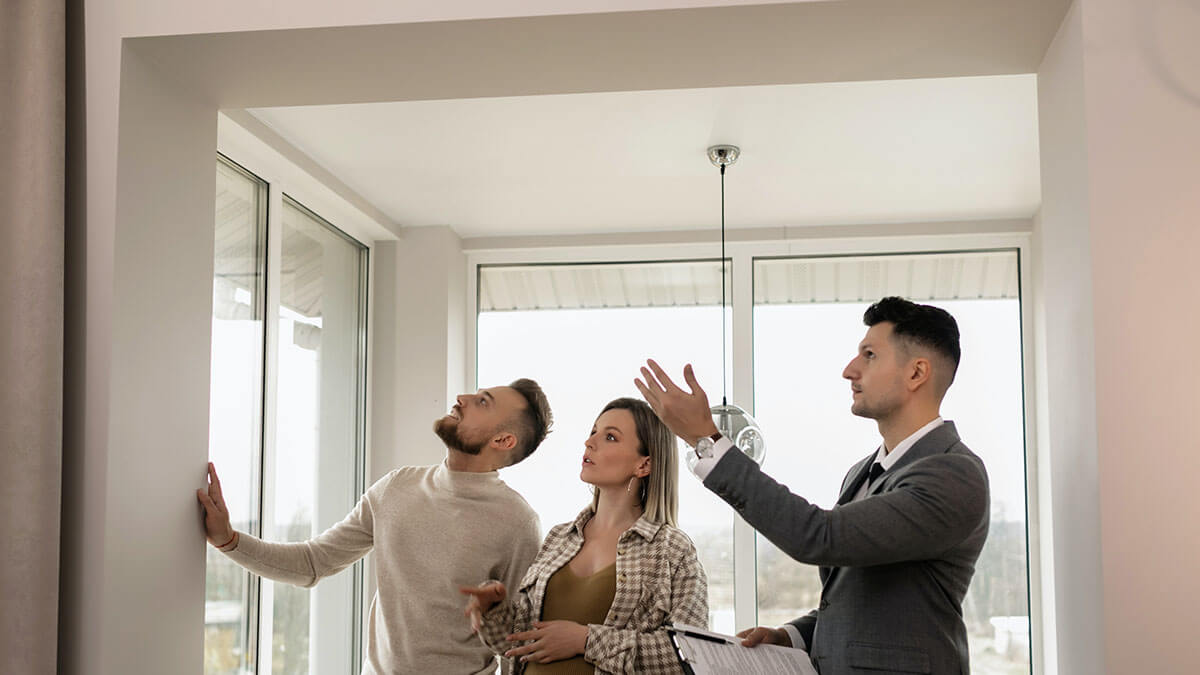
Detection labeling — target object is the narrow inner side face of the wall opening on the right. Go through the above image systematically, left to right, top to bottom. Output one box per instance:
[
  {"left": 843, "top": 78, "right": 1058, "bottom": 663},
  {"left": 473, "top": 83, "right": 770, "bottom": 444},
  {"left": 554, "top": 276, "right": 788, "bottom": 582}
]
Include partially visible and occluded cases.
[{"left": 1034, "top": 6, "right": 1104, "bottom": 675}]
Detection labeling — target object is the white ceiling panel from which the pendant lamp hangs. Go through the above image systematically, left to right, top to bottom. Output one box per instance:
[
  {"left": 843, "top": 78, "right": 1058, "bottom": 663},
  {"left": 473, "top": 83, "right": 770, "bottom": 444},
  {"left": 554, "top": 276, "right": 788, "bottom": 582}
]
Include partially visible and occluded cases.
[{"left": 251, "top": 74, "right": 1040, "bottom": 237}]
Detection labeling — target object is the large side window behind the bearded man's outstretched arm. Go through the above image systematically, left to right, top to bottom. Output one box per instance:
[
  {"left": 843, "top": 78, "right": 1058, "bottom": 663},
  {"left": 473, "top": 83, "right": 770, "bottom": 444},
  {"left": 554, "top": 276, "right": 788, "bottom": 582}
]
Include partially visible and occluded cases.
[{"left": 205, "top": 159, "right": 367, "bottom": 675}]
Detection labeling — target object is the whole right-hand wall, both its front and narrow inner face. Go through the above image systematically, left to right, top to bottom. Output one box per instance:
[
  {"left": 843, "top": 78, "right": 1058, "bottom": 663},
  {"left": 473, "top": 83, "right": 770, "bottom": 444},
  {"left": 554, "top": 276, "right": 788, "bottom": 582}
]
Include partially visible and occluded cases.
[{"left": 1037, "top": 0, "right": 1200, "bottom": 674}]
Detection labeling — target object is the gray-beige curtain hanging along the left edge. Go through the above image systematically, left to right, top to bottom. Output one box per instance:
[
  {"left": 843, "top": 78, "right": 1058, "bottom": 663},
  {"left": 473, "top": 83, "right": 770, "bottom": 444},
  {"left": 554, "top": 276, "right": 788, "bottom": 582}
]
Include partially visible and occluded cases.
[{"left": 0, "top": 0, "right": 66, "bottom": 674}]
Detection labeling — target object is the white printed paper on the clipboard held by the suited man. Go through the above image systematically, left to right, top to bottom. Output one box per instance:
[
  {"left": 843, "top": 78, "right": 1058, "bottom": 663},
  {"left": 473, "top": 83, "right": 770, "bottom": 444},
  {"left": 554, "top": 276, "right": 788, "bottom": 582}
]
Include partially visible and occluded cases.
[{"left": 667, "top": 623, "right": 817, "bottom": 675}]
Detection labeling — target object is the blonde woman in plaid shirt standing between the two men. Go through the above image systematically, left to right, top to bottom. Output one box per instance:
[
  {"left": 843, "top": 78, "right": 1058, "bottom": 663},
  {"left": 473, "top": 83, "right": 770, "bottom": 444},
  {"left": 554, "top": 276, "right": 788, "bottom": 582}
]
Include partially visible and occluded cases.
[{"left": 462, "top": 399, "right": 708, "bottom": 675}]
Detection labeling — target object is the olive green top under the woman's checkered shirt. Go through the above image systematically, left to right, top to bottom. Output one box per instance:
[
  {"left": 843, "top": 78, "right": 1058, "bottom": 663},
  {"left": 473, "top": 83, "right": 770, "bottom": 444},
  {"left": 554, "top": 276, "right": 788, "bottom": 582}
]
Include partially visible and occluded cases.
[{"left": 524, "top": 562, "right": 617, "bottom": 675}]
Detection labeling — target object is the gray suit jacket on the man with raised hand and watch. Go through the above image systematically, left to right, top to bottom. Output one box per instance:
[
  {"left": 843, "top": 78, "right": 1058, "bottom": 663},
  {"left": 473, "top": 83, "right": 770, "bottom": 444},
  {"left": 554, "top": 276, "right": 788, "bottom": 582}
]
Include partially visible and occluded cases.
[{"left": 704, "top": 422, "right": 989, "bottom": 675}]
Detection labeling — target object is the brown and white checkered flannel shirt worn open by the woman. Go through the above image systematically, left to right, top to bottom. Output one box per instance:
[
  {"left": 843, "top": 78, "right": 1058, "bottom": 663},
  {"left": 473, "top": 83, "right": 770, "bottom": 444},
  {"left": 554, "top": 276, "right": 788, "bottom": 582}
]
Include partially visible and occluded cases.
[{"left": 479, "top": 506, "right": 708, "bottom": 674}]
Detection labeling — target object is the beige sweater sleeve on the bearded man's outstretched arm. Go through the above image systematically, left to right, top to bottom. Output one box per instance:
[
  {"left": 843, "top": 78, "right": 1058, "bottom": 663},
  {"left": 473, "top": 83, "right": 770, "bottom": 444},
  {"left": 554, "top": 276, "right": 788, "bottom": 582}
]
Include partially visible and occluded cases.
[{"left": 223, "top": 478, "right": 386, "bottom": 589}]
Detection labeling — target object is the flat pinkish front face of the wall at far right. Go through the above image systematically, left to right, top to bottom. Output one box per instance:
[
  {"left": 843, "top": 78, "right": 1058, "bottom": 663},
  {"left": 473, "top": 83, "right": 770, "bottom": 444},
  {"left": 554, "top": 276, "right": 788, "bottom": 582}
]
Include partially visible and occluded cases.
[{"left": 1082, "top": 0, "right": 1200, "bottom": 674}]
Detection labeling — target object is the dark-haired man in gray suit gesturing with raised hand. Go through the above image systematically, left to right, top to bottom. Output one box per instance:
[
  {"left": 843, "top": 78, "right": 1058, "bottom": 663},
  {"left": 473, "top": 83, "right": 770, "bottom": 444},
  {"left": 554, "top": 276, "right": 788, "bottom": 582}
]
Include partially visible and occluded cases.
[{"left": 635, "top": 298, "right": 989, "bottom": 675}]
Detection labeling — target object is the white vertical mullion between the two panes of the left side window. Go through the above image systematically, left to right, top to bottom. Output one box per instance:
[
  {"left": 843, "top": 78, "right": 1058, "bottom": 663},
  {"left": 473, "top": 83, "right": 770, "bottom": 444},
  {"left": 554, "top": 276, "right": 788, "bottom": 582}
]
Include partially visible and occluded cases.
[{"left": 258, "top": 183, "right": 283, "bottom": 674}]
